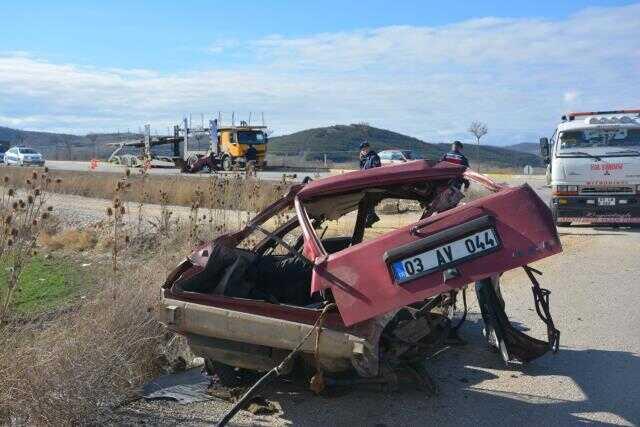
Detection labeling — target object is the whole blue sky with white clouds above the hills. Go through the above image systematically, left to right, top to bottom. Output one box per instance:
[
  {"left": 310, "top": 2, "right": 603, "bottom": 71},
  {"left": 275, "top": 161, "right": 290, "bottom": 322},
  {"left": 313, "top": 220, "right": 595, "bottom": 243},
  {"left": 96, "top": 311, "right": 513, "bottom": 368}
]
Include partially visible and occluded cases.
[{"left": 0, "top": 0, "right": 640, "bottom": 145}]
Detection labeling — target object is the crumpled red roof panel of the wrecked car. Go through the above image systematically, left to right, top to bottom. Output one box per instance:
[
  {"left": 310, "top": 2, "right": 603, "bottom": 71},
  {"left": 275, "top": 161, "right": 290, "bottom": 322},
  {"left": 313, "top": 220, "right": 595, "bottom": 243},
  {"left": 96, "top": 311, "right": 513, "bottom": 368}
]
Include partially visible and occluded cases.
[{"left": 298, "top": 160, "right": 466, "bottom": 200}]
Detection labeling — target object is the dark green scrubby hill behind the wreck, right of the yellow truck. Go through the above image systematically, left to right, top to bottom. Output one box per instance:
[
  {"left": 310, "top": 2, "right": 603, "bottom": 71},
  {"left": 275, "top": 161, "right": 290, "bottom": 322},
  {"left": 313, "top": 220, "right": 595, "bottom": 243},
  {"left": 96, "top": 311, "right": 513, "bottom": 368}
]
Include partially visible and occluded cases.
[{"left": 269, "top": 124, "right": 542, "bottom": 167}]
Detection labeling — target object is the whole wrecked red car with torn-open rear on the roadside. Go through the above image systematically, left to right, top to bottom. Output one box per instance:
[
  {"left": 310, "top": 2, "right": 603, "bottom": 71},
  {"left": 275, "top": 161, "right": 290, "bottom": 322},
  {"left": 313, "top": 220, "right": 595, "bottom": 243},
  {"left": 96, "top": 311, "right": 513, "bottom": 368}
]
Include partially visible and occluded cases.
[{"left": 162, "top": 160, "right": 562, "bottom": 392}]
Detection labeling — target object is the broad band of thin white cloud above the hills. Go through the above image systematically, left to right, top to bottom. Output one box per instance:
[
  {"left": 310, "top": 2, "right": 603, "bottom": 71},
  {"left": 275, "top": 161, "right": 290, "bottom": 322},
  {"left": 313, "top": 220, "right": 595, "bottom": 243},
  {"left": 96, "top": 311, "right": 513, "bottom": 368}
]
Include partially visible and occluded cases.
[{"left": 0, "top": 4, "right": 640, "bottom": 144}]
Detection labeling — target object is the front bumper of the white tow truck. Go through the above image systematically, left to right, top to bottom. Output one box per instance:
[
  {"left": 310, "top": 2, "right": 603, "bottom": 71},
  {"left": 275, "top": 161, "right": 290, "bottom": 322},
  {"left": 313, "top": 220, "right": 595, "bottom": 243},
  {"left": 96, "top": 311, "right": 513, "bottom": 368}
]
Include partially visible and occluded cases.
[{"left": 551, "top": 194, "right": 640, "bottom": 224}]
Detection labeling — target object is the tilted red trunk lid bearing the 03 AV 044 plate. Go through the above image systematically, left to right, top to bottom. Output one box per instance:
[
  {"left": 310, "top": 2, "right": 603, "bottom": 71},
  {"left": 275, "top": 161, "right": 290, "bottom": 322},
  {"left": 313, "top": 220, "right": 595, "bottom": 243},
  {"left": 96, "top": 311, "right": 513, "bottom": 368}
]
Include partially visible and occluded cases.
[{"left": 303, "top": 185, "right": 562, "bottom": 325}]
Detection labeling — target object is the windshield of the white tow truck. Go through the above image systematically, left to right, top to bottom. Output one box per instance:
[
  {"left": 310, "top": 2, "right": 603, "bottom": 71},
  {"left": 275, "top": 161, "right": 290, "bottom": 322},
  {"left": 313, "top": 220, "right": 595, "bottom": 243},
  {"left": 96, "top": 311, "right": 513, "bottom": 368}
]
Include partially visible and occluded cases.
[{"left": 560, "top": 129, "right": 640, "bottom": 152}]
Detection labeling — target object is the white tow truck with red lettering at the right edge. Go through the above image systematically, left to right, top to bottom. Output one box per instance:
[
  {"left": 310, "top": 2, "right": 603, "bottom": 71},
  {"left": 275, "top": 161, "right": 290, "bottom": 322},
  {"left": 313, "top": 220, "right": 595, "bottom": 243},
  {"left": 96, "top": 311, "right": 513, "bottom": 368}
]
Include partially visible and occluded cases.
[{"left": 540, "top": 110, "right": 640, "bottom": 226}]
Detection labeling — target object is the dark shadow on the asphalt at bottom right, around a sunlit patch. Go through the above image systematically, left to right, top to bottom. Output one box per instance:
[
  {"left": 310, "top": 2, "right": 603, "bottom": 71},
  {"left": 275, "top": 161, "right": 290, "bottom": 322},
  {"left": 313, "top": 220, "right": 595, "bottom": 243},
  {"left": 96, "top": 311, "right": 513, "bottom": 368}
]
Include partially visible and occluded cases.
[{"left": 268, "top": 320, "right": 640, "bottom": 426}]
